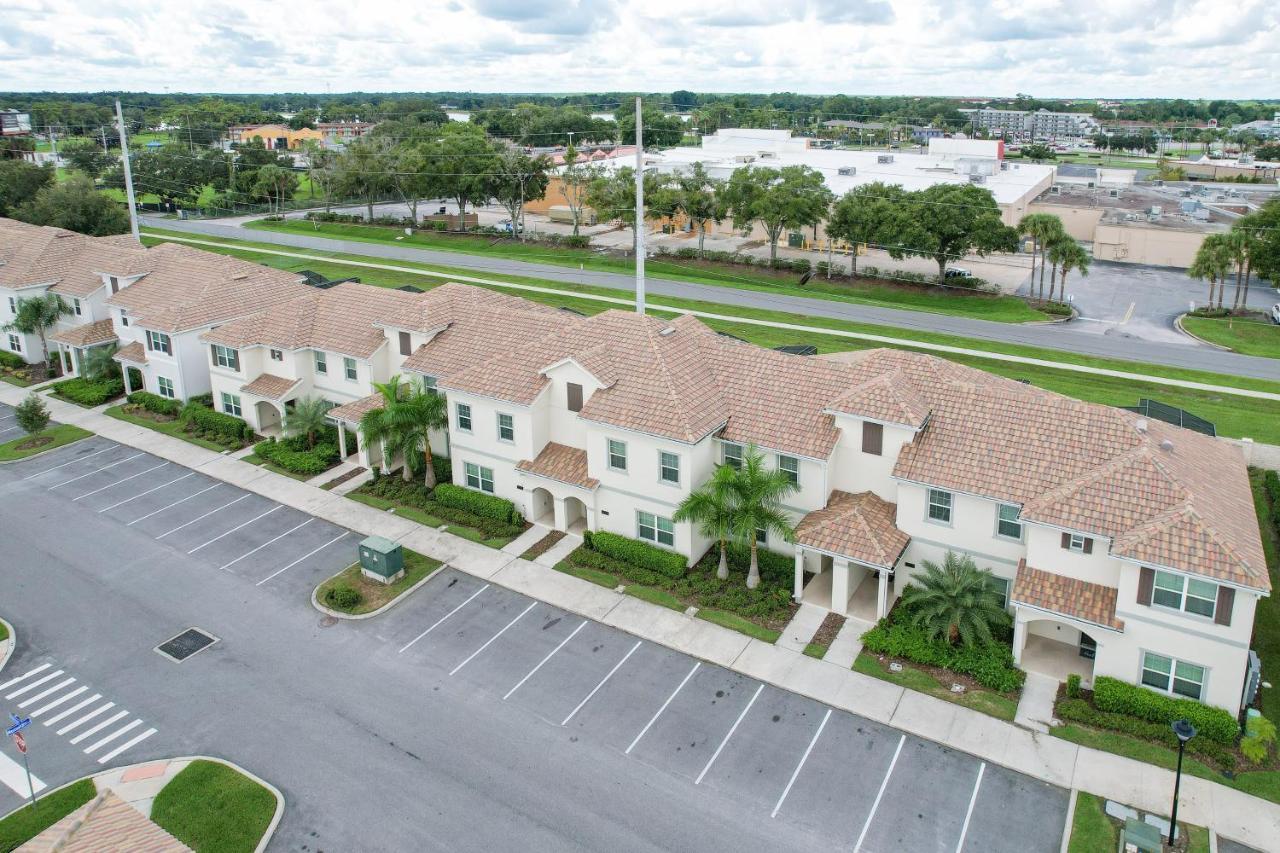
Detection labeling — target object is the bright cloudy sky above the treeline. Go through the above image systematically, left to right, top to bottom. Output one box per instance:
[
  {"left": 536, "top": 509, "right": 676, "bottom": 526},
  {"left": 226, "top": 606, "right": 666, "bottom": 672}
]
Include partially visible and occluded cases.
[{"left": 0, "top": 0, "right": 1280, "bottom": 97}]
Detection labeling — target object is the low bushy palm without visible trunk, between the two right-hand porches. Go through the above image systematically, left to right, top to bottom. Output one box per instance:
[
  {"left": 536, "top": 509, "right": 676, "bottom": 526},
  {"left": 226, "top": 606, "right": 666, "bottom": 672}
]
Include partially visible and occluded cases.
[{"left": 902, "top": 551, "right": 1009, "bottom": 647}]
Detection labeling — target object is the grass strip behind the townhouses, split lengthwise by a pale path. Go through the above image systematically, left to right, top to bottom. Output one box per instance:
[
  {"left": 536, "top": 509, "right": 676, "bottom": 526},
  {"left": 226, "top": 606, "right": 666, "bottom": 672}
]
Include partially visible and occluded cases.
[{"left": 145, "top": 232, "right": 1280, "bottom": 444}]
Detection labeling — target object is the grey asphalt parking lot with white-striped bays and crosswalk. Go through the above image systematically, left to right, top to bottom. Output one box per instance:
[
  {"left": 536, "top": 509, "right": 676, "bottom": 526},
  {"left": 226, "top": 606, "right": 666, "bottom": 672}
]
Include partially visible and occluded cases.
[{"left": 0, "top": 438, "right": 1068, "bottom": 853}]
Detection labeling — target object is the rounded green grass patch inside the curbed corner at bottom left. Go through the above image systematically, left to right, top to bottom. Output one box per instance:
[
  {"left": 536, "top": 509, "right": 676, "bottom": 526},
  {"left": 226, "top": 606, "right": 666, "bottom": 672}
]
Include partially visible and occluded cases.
[{"left": 151, "top": 761, "right": 275, "bottom": 853}]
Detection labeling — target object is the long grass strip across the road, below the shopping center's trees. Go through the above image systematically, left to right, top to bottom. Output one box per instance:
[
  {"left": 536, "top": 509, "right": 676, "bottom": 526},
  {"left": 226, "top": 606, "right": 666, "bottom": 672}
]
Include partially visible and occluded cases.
[{"left": 246, "top": 219, "right": 1047, "bottom": 323}]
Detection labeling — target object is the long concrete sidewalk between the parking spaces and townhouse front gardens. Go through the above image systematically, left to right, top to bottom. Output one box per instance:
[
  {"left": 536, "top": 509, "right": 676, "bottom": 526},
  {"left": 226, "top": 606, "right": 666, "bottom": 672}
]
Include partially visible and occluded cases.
[{"left": 0, "top": 387, "right": 1280, "bottom": 849}]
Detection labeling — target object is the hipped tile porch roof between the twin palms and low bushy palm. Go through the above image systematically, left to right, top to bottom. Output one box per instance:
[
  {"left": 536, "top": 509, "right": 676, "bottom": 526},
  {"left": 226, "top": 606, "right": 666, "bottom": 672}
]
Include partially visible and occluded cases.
[{"left": 795, "top": 491, "right": 911, "bottom": 569}]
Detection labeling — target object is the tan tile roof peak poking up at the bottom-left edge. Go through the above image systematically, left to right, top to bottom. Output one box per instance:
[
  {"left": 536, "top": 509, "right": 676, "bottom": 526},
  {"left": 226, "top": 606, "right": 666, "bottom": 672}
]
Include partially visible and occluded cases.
[{"left": 18, "top": 790, "right": 191, "bottom": 853}]
